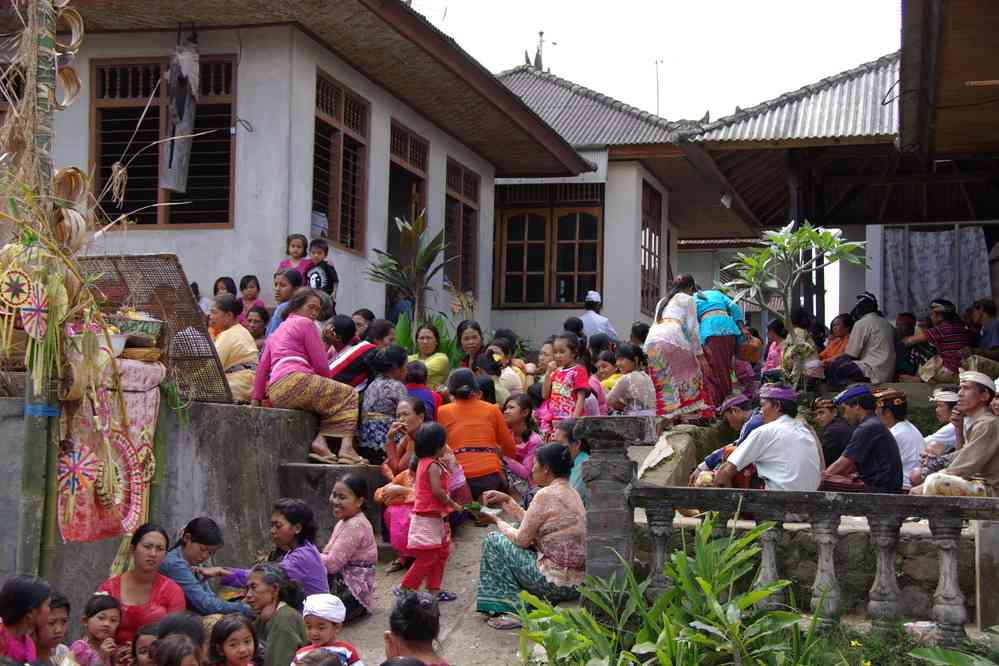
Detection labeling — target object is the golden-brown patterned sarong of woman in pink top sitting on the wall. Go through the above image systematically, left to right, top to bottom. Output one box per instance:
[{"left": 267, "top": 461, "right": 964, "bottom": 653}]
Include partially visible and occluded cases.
[{"left": 267, "top": 372, "right": 357, "bottom": 437}]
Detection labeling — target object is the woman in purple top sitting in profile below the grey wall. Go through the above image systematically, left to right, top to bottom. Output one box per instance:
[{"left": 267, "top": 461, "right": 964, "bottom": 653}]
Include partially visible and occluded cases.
[{"left": 222, "top": 497, "right": 330, "bottom": 592}]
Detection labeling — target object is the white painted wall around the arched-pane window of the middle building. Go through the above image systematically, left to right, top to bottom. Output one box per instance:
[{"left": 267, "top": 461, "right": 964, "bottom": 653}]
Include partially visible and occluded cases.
[{"left": 493, "top": 159, "right": 676, "bottom": 344}]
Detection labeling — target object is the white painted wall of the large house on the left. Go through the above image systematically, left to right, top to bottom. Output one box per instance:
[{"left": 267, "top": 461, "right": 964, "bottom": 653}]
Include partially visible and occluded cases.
[{"left": 55, "top": 26, "right": 494, "bottom": 326}]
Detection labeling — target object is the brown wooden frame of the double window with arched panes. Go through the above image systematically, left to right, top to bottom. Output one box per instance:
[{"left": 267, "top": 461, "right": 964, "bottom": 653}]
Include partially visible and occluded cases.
[{"left": 493, "top": 202, "right": 604, "bottom": 310}]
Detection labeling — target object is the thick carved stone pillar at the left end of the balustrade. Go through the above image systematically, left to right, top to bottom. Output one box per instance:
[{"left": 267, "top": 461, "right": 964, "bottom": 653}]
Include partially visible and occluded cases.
[{"left": 575, "top": 416, "right": 646, "bottom": 578}]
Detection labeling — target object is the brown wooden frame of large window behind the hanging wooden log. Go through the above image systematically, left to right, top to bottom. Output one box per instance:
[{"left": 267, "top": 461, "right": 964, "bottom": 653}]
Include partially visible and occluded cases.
[{"left": 89, "top": 54, "right": 239, "bottom": 231}]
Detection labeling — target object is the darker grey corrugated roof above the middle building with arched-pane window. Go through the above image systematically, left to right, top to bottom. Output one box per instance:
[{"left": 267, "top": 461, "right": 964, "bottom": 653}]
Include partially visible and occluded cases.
[{"left": 496, "top": 65, "right": 699, "bottom": 148}]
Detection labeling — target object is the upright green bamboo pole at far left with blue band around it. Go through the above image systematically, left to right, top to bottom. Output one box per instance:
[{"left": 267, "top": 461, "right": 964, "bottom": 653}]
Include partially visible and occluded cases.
[{"left": 17, "top": 0, "right": 56, "bottom": 573}]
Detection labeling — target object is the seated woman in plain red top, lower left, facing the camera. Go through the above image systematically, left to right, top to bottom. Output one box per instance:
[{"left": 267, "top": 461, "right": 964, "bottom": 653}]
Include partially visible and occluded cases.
[{"left": 97, "top": 523, "right": 185, "bottom": 646}]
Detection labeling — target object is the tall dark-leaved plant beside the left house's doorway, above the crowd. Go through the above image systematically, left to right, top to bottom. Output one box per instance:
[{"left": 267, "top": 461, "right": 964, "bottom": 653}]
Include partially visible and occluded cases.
[{"left": 365, "top": 211, "right": 457, "bottom": 322}]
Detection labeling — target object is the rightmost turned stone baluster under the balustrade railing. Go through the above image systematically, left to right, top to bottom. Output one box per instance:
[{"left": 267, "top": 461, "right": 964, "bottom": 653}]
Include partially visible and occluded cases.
[{"left": 930, "top": 514, "right": 968, "bottom": 645}]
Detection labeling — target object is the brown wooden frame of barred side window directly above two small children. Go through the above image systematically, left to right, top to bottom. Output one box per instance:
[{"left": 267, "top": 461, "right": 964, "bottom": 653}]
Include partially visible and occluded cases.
[{"left": 312, "top": 71, "right": 371, "bottom": 257}]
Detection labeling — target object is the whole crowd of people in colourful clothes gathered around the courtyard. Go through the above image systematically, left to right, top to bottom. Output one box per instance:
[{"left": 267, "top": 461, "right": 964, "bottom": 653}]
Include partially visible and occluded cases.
[{"left": 7, "top": 236, "right": 999, "bottom": 666}]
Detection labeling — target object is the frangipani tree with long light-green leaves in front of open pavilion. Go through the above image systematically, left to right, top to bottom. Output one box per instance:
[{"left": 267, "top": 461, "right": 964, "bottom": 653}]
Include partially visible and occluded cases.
[{"left": 721, "top": 222, "right": 866, "bottom": 330}]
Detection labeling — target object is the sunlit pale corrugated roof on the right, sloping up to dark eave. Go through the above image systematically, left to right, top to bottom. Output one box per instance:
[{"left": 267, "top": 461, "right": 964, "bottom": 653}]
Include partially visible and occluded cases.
[{"left": 692, "top": 52, "right": 899, "bottom": 142}]
